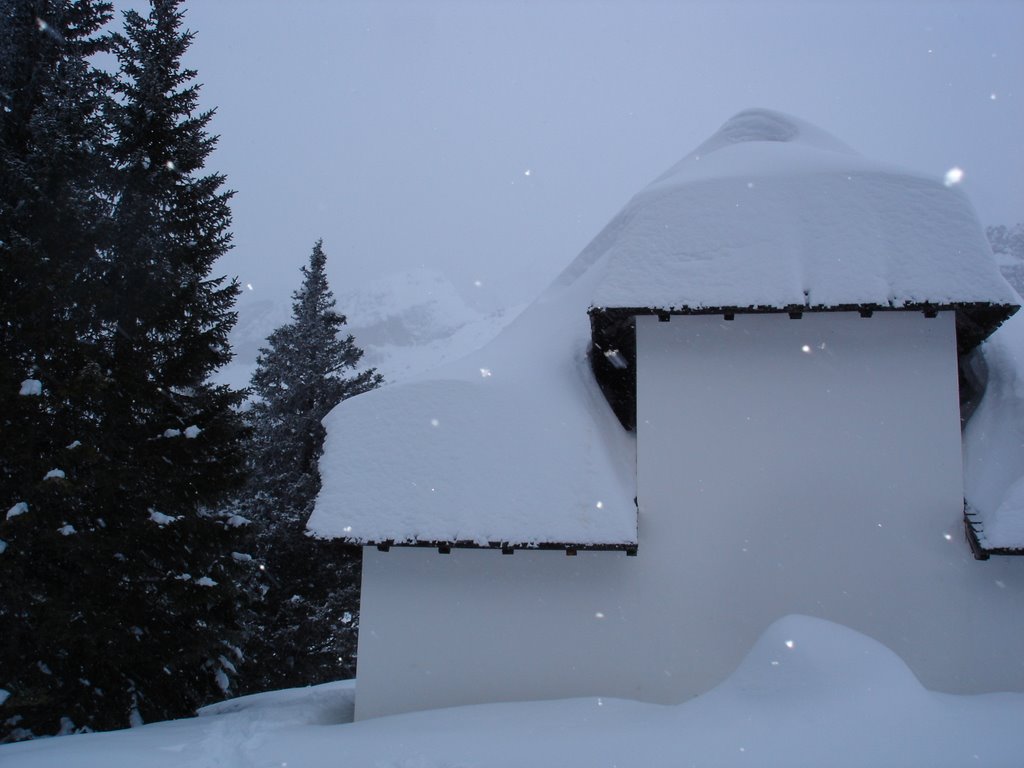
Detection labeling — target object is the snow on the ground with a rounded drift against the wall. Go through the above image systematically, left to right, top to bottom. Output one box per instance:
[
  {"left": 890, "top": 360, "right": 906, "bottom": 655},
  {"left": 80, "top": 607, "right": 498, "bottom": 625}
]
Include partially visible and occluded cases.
[{"left": 0, "top": 615, "right": 1024, "bottom": 768}]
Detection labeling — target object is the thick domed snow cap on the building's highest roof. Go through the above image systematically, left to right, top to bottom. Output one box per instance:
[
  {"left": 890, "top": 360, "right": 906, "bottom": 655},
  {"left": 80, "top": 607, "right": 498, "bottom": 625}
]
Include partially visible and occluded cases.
[{"left": 581, "top": 110, "right": 1019, "bottom": 309}]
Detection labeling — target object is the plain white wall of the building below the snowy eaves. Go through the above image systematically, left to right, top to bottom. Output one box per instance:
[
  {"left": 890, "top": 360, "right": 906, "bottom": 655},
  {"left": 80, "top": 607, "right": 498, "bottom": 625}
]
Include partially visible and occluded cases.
[{"left": 356, "top": 313, "right": 1024, "bottom": 719}]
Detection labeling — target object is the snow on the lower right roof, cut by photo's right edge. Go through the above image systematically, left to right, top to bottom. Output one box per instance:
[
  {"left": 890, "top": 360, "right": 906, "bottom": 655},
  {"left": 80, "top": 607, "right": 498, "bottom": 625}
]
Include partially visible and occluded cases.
[{"left": 964, "top": 314, "right": 1024, "bottom": 549}]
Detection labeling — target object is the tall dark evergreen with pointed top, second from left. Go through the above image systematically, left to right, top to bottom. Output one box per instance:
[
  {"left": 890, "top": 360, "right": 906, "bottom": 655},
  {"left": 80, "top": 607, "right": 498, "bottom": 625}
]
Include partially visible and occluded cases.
[{"left": 0, "top": 0, "right": 251, "bottom": 739}]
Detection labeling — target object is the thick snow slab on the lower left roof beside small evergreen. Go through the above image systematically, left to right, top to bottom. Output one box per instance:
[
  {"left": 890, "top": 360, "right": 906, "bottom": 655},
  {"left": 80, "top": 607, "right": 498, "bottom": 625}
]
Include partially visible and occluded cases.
[{"left": 308, "top": 249, "right": 637, "bottom": 545}]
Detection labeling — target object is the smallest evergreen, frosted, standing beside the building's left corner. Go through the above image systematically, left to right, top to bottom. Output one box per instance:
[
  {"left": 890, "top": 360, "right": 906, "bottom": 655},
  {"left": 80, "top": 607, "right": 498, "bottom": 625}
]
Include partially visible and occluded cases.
[{"left": 240, "top": 241, "right": 383, "bottom": 690}]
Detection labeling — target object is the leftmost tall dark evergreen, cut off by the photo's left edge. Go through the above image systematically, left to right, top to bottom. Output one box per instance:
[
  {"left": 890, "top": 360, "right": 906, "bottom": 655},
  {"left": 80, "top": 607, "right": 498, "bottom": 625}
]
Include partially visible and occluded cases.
[{"left": 0, "top": 0, "right": 119, "bottom": 740}]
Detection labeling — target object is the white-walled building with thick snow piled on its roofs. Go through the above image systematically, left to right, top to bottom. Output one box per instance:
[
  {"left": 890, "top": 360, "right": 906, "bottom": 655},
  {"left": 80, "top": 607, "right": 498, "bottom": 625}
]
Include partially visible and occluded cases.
[{"left": 309, "top": 110, "right": 1024, "bottom": 719}]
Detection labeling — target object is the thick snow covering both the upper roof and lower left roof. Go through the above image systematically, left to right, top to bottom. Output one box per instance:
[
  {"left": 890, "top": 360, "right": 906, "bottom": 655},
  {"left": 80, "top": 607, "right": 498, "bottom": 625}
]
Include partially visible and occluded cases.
[{"left": 308, "top": 111, "right": 1016, "bottom": 549}]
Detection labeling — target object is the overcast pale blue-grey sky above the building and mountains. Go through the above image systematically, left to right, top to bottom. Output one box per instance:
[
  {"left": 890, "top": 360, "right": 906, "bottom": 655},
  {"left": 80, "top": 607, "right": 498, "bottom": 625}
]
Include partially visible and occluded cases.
[{"left": 121, "top": 0, "right": 1024, "bottom": 309}]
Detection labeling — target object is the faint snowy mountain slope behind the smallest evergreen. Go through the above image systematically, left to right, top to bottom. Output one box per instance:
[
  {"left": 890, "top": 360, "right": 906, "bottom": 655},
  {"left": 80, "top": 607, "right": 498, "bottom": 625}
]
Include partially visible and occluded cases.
[{"left": 217, "top": 269, "right": 517, "bottom": 388}]
